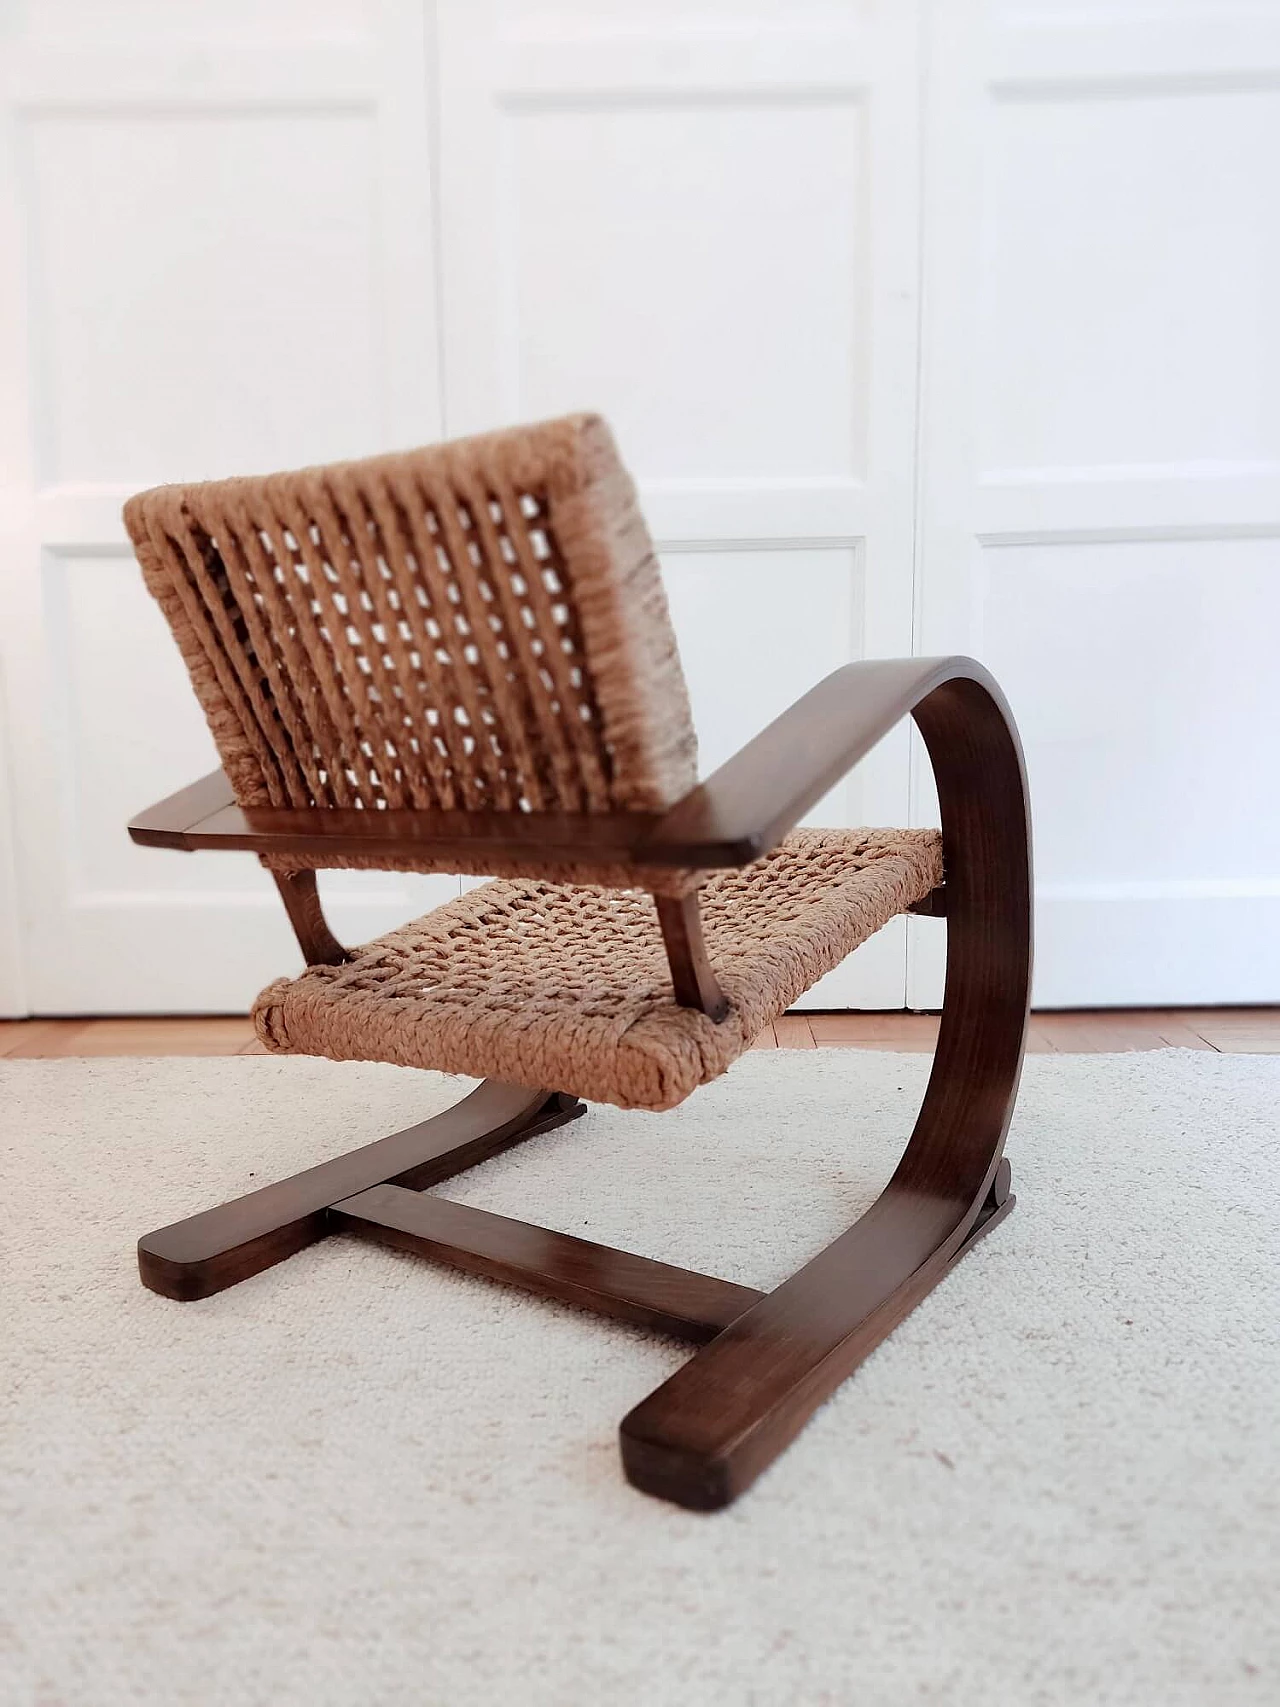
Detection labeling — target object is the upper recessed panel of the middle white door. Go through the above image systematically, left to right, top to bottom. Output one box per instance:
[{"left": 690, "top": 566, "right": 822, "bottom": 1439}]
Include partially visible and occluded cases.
[{"left": 494, "top": 90, "right": 867, "bottom": 483}]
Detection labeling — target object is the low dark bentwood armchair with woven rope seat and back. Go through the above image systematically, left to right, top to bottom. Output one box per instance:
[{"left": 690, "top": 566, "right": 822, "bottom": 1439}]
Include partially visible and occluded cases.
[{"left": 125, "top": 415, "right": 1031, "bottom": 1509}]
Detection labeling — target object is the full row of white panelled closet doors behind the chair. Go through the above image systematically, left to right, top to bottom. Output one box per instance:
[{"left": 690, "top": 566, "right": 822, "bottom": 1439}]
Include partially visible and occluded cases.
[{"left": 0, "top": 0, "right": 1280, "bottom": 1012}]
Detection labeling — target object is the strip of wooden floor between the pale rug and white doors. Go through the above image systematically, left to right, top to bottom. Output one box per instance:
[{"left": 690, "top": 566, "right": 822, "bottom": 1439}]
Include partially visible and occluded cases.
[{"left": 0, "top": 1007, "right": 1280, "bottom": 1058}]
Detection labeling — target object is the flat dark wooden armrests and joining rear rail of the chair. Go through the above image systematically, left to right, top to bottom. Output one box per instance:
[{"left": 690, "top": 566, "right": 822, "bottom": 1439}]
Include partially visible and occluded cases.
[{"left": 130, "top": 657, "right": 1009, "bottom": 871}]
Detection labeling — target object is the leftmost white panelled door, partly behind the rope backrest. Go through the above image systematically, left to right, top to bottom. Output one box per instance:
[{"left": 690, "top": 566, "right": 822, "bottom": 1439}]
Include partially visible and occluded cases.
[{"left": 0, "top": 0, "right": 457, "bottom": 1014}]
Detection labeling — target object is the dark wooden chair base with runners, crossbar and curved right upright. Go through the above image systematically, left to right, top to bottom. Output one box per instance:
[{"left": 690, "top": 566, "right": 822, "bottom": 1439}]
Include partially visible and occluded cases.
[{"left": 138, "top": 678, "right": 1031, "bottom": 1511}]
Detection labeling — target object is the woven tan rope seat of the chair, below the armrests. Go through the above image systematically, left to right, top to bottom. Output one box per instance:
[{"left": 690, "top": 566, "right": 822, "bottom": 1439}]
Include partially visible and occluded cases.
[{"left": 254, "top": 830, "right": 942, "bottom": 1110}]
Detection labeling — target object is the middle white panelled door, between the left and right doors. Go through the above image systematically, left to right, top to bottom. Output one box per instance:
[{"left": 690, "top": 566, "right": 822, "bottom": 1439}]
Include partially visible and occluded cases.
[{"left": 439, "top": 0, "right": 918, "bottom": 1007}]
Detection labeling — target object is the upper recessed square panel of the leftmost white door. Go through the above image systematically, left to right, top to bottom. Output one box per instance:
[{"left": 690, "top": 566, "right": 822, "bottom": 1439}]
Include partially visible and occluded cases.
[{"left": 24, "top": 104, "right": 382, "bottom": 486}]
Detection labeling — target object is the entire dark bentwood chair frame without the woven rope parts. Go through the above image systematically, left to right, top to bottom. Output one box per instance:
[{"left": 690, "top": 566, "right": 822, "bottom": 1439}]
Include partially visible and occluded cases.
[{"left": 130, "top": 657, "right": 1031, "bottom": 1511}]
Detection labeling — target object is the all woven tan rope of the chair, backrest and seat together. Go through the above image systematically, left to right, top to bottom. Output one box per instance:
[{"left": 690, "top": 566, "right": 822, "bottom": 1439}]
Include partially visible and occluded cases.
[{"left": 133, "top": 415, "right": 942, "bottom": 1110}]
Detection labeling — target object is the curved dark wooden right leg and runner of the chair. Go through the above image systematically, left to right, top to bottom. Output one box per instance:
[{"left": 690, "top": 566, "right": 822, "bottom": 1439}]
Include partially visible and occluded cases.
[{"left": 621, "top": 681, "right": 1031, "bottom": 1511}]
